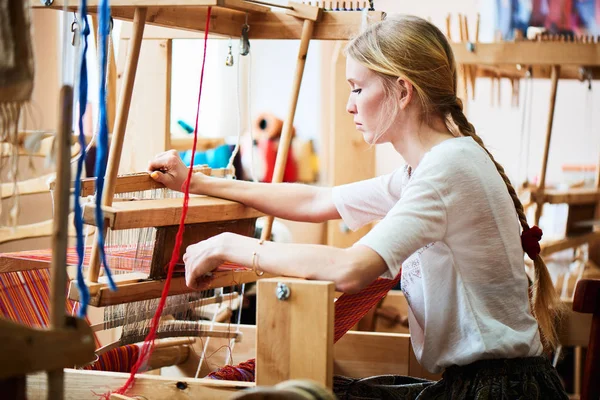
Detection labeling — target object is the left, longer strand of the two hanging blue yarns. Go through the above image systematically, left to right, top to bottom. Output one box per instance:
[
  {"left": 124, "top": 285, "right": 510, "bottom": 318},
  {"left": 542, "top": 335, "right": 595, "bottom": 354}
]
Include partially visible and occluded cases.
[{"left": 73, "top": 0, "right": 90, "bottom": 318}]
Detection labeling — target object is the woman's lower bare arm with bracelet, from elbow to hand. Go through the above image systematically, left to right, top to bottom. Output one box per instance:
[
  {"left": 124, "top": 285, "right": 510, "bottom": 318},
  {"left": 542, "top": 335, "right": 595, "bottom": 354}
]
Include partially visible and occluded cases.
[{"left": 183, "top": 233, "right": 387, "bottom": 293}]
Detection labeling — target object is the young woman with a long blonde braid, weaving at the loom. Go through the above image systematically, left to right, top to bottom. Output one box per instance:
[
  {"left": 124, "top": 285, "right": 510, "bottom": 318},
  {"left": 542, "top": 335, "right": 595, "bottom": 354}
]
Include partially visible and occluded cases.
[{"left": 149, "top": 16, "right": 567, "bottom": 399}]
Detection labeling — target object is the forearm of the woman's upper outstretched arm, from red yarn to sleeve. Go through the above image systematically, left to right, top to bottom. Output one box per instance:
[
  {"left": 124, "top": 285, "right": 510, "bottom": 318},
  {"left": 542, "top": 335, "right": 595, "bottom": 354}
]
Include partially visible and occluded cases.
[{"left": 191, "top": 175, "right": 340, "bottom": 222}]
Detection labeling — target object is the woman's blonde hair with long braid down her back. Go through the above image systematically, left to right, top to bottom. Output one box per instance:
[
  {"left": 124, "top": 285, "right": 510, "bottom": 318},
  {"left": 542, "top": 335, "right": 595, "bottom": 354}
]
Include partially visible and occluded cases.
[{"left": 346, "top": 15, "right": 562, "bottom": 349}]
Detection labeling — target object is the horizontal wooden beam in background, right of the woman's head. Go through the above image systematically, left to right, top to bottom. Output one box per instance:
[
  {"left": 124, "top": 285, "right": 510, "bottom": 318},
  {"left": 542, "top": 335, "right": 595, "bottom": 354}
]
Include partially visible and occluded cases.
[{"left": 450, "top": 41, "right": 600, "bottom": 66}]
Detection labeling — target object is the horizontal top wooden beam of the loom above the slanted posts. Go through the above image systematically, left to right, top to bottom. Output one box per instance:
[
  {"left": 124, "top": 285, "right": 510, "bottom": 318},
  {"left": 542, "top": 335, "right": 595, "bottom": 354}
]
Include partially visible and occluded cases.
[{"left": 33, "top": 0, "right": 384, "bottom": 40}]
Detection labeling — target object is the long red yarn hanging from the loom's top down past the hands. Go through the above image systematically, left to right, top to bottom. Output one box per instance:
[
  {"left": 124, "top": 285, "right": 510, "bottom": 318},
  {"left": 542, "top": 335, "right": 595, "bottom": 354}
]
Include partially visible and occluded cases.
[{"left": 105, "top": 7, "right": 212, "bottom": 399}]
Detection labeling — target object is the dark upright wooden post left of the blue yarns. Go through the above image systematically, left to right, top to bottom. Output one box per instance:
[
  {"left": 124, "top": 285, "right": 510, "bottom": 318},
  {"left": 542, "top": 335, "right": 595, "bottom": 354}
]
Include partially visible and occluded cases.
[{"left": 48, "top": 85, "right": 73, "bottom": 399}]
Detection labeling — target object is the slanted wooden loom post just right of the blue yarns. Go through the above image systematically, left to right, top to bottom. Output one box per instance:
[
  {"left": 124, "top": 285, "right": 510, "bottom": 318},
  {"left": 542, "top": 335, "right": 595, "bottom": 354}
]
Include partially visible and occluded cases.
[{"left": 88, "top": 7, "right": 147, "bottom": 282}]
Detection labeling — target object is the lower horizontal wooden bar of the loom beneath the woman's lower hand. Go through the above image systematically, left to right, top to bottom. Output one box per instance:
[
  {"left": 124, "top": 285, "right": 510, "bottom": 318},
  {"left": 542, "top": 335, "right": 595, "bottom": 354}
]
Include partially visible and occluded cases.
[{"left": 69, "top": 270, "right": 273, "bottom": 307}]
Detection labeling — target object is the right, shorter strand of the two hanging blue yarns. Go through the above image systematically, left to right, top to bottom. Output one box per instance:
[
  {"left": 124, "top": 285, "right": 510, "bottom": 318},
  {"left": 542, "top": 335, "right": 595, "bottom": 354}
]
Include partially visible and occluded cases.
[{"left": 95, "top": 0, "right": 117, "bottom": 290}]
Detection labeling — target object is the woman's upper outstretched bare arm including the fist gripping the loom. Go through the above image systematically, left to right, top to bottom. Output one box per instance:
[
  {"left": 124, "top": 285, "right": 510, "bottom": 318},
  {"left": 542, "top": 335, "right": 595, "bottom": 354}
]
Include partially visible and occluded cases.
[{"left": 148, "top": 150, "right": 340, "bottom": 222}]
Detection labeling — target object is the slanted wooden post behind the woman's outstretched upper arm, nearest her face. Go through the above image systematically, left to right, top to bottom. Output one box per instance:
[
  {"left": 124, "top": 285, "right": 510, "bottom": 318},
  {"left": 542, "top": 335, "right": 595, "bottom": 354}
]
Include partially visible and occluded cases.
[{"left": 261, "top": 19, "right": 315, "bottom": 240}]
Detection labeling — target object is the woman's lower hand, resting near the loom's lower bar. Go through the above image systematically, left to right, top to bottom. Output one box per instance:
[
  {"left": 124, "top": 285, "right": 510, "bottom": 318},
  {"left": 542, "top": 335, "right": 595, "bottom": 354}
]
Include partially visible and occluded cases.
[{"left": 183, "top": 232, "right": 229, "bottom": 289}]
